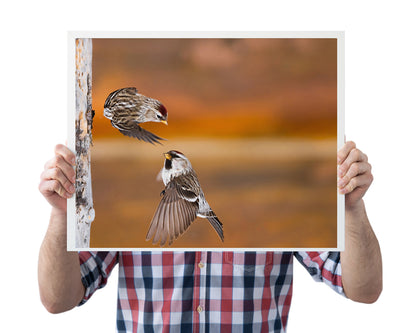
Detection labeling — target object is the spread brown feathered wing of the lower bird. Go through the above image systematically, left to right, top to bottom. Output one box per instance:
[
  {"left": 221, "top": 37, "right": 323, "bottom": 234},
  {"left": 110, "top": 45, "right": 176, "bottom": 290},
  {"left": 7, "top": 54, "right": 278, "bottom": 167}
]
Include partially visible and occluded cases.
[{"left": 146, "top": 179, "right": 199, "bottom": 246}]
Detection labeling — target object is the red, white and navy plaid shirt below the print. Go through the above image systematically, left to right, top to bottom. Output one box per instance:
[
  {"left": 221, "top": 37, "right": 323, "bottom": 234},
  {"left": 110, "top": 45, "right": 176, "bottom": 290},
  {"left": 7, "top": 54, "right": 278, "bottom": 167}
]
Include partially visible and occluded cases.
[{"left": 79, "top": 252, "right": 343, "bottom": 332}]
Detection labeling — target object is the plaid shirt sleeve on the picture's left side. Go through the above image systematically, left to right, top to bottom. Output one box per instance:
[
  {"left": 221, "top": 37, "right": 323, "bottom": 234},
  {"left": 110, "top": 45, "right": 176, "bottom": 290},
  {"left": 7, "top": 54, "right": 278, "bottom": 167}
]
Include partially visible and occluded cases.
[{"left": 78, "top": 252, "right": 118, "bottom": 305}]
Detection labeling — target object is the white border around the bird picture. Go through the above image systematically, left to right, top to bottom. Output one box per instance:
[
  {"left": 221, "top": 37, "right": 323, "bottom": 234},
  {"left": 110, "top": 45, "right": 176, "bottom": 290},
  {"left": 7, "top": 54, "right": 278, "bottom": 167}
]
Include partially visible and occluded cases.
[{"left": 67, "top": 31, "right": 345, "bottom": 252}]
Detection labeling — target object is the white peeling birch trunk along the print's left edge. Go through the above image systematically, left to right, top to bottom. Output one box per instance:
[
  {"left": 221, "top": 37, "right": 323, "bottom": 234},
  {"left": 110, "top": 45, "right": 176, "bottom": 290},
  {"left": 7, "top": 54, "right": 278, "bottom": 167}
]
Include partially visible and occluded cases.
[{"left": 75, "top": 38, "right": 95, "bottom": 248}]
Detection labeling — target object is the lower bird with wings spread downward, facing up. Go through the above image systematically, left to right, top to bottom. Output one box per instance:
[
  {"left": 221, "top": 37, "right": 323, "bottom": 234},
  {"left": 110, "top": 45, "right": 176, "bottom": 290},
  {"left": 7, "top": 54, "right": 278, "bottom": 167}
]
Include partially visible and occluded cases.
[{"left": 146, "top": 150, "right": 224, "bottom": 246}]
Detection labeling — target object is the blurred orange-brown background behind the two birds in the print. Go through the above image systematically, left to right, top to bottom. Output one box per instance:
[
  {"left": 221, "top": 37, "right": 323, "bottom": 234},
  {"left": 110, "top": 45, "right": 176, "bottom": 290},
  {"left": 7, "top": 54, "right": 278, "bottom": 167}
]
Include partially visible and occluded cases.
[{"left": 91, "top": 38, "right": 337, "bottom": 248}]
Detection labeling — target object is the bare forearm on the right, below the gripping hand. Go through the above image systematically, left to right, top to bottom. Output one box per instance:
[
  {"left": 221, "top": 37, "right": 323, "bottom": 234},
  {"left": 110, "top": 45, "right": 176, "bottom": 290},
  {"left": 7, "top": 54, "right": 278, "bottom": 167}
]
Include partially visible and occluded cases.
[{"left": 341, "top": 200, "right": 383, "bottom": 303}]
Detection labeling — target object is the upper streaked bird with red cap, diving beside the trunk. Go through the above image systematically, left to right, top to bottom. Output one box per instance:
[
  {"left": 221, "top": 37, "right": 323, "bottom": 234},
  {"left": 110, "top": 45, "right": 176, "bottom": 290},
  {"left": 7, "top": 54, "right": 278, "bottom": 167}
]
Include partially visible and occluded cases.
[{"left": 104, "top": 87, "right": 168, "bottom": 144}]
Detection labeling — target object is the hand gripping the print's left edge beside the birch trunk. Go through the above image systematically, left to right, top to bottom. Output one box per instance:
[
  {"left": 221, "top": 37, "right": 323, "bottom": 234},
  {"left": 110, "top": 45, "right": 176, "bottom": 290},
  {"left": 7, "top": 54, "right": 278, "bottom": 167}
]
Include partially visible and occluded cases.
[{"left": 39, "top": 144, "right": 75, "bottom": 214}]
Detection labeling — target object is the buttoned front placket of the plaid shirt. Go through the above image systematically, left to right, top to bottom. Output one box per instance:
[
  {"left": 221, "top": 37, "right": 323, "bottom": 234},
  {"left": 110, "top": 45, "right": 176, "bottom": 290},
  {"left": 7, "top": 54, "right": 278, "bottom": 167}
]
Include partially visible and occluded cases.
[{"left": 193, "top": 252, "right": 207, "bottom": 332}]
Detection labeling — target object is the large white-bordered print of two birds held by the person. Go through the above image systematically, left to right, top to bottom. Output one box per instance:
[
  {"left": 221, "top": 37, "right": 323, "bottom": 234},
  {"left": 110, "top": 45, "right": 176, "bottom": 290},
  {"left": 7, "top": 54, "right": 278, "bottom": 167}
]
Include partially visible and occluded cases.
[{"left": 68, "top": 32, "right": 345, "bottom": 251}]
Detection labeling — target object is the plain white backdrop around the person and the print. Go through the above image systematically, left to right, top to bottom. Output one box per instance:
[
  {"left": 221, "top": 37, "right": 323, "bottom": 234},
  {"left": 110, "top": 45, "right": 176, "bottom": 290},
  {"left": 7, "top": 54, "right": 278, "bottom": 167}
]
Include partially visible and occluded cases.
[{"left": 0, "top": 0, "right": 416, "bottom": 333}]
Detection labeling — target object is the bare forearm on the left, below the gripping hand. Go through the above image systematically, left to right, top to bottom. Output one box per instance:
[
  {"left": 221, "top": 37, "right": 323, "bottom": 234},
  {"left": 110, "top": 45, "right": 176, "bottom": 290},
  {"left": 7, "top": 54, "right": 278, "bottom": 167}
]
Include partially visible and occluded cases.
[{"left": 38, "top": 209, "right": 84, "bottom": 313}]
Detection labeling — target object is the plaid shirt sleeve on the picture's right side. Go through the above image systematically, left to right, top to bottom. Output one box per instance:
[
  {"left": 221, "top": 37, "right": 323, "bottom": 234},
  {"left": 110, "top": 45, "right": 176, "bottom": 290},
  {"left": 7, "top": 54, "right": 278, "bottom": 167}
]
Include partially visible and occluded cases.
[{"left": 294, "top": 252, "right": 345, "bottom": 296}]
